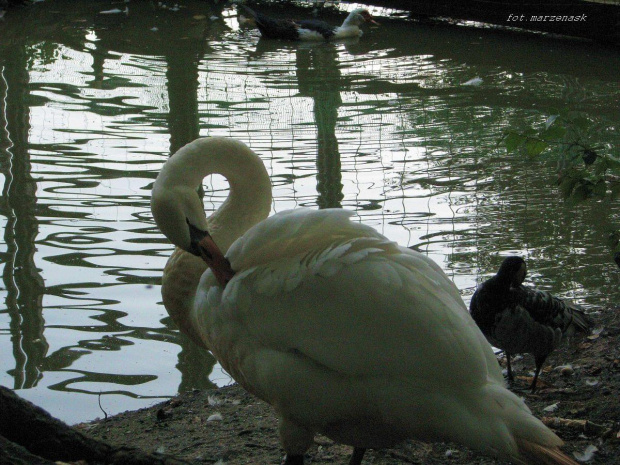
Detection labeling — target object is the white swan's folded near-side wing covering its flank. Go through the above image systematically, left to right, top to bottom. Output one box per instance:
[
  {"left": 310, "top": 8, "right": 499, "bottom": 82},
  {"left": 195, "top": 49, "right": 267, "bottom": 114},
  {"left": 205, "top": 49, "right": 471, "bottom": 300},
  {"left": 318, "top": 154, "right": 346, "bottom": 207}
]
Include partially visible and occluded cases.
[{"left": 195, "top": 210, "right": 501, "bottom": 384}]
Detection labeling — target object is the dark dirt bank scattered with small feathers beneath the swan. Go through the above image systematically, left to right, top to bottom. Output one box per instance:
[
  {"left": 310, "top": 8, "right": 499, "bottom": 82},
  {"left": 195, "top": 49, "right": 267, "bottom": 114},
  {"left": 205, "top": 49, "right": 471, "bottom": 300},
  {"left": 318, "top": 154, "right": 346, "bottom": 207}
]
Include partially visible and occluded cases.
[{"left": 77, "top": 308, "right": 620, "bottom": 465}]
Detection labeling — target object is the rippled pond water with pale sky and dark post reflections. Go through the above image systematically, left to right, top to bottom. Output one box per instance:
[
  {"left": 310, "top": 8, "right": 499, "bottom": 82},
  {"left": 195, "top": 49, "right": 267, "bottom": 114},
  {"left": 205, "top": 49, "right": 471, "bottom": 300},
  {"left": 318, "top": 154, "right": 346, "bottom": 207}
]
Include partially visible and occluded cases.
[{"left": 0, "top": 0, "right": 620, "bottom": 423}]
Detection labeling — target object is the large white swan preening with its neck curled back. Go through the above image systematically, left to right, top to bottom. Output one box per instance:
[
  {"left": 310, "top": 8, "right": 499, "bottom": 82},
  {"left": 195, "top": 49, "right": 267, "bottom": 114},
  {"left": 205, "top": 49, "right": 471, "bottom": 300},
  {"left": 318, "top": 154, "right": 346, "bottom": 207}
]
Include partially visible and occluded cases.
[{"left": 151, "top": 138, "right": 576, "bottom": 464}]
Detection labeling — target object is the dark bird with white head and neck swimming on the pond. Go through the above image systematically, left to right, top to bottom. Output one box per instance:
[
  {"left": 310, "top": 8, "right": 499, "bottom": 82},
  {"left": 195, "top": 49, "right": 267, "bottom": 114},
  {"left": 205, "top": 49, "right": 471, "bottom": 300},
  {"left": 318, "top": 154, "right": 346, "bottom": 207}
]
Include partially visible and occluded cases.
[{"left": 240, "top": 5, "right": 378, "bottom": 41}]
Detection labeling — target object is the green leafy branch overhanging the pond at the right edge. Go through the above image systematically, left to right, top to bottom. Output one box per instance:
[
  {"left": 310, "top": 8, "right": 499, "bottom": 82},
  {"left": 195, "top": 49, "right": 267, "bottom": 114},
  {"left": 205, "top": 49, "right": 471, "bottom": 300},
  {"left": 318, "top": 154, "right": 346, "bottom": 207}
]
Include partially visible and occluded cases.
[{"left": 499, "top": 112, "right": 620, "bottom": 202}]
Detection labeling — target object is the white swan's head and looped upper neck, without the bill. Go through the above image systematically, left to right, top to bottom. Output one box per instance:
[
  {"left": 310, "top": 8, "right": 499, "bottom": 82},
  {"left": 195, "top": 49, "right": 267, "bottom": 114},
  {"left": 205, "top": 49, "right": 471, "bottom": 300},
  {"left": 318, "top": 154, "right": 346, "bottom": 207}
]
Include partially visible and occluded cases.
[{"left": 151, "top": 137, "right": 272, "bottom": 253}]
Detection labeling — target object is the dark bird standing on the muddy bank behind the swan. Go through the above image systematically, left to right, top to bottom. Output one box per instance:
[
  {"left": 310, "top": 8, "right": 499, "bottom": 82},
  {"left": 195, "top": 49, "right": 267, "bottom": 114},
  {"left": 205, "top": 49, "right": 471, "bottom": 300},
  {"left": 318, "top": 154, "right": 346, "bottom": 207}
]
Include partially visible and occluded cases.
[{"left": 469, "top": 257, "right": 591, "bottom": 392}]
